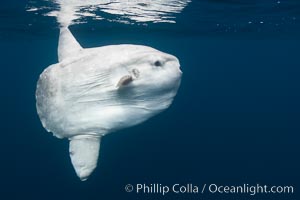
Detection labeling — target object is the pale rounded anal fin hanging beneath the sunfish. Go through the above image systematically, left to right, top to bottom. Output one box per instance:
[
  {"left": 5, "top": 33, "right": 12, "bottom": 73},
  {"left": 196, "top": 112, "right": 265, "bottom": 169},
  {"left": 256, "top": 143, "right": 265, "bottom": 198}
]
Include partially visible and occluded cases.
[{"left": 69, "top": 135, "right": 101, "bottom": 181}]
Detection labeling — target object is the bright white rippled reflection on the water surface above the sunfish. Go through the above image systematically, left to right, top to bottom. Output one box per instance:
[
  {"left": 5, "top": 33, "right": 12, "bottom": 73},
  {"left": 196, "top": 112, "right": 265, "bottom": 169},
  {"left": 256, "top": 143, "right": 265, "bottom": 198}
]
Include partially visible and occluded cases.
[{"left": 27, "top": 0, "right": 191, "bottom": 26}]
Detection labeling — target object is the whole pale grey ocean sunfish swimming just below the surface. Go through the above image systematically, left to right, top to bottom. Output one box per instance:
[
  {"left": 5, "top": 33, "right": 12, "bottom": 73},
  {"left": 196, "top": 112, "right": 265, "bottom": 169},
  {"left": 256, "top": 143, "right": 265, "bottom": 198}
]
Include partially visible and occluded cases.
[{"left": 36, "top": 27, "right": 182, "bottom": 180}]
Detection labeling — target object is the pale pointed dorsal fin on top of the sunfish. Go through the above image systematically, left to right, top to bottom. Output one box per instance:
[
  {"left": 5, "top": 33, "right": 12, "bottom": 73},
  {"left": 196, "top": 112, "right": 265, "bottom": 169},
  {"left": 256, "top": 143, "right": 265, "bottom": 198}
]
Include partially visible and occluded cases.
[{"left": 57, "top": 27, "right": 82, "bottom": 62}]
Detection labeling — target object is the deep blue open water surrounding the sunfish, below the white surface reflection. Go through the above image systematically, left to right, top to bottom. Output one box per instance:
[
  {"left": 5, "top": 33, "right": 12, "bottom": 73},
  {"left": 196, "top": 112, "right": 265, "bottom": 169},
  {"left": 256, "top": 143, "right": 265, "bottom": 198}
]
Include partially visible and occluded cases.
[{"left": 0, "top": 0, "right": 300, "bottom": 200}]
